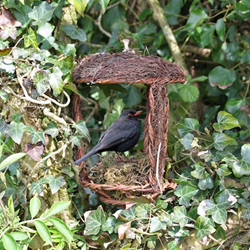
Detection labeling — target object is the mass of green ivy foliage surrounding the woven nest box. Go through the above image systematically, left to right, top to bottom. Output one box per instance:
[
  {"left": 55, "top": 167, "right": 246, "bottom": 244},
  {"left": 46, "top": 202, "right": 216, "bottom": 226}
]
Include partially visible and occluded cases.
[{"left": 0, "top": 0, "right": 250, "bottom": 250}]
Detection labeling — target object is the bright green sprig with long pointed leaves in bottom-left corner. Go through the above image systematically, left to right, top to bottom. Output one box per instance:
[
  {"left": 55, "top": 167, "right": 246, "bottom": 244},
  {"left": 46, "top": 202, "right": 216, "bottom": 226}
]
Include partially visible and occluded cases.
[{"left": 0, "top": 196, "right": 82, "bottom": 250}]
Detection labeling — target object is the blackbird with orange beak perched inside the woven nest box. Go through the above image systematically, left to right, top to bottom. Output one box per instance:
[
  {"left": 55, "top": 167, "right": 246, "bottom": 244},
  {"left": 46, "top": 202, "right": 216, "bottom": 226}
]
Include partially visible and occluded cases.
[{"left": 74, "top": 109, "right": 142, "bottom": 165}]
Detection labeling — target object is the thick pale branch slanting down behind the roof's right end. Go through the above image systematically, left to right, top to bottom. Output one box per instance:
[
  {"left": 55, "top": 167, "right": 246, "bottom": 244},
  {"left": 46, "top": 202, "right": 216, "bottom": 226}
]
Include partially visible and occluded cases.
[{"left": 148, "top": 0, "right": 187, "bottom": 70}]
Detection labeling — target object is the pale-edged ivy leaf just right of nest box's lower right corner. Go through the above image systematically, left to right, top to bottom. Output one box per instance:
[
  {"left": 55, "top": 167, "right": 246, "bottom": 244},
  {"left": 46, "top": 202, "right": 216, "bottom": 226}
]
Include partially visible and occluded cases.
[{"left": 174, "top": 184, "right": 198, "bottom": 207}]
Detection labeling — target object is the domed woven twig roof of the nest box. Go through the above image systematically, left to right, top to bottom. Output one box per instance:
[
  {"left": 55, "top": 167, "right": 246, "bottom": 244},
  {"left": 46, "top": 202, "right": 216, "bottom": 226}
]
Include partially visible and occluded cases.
[{"left": 73, "top": 52, "right": 186, "bottom": 85}]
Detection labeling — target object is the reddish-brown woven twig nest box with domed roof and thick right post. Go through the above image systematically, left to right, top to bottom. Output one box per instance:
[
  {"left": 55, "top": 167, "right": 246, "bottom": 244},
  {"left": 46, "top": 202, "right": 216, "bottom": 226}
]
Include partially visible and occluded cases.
[{"left": 73, "top": 52, "right": 186, "bottom": 204}]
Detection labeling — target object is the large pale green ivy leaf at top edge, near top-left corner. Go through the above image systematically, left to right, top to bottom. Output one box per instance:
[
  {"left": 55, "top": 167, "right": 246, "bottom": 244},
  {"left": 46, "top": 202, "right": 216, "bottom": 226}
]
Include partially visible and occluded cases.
[{"left": 28, "top": 1, "right": 56, "bottom": 27}]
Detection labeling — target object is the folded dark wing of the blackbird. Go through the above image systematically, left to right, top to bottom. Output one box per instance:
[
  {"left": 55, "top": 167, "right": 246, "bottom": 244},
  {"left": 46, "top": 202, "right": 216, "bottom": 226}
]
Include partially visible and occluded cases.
[{"left": 98, "top": 121, "right": 137, "bottom": 149}]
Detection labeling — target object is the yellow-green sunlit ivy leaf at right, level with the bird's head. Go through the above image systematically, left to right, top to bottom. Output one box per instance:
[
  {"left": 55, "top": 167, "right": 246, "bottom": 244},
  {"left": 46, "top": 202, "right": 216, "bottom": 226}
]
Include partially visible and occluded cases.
[{"left": 213, "top": 111, "right": 240, "bottom": 132}]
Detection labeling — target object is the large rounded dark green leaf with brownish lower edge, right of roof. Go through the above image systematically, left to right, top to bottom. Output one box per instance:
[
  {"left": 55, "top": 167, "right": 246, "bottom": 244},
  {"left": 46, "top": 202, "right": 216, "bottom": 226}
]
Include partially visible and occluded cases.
[{"left": 208, "top": 66, "right": 236, "bottom": 89}]
